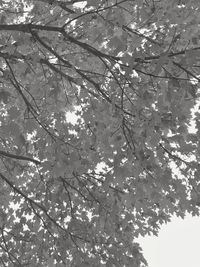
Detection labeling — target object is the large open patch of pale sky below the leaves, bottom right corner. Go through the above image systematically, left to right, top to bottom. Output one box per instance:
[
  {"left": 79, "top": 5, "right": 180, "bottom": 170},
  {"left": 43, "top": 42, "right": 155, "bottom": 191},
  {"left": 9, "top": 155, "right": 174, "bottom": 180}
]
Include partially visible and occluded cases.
[{"left": 138, "top": 215, "right": 200, "bottom": 267}]
